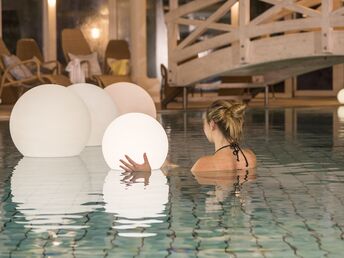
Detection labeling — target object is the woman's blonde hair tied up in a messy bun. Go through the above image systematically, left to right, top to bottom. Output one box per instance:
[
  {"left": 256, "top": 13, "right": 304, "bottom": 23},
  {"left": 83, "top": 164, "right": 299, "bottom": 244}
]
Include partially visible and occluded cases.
[{"left": 206, "top": 100, "right": 246, "bottom": 142}]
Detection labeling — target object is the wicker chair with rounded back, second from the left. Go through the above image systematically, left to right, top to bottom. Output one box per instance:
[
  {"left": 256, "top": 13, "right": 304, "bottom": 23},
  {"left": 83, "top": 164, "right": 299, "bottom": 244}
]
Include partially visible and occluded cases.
[{"left": 16, "top": 38, "right": 61, "bottom": 74}]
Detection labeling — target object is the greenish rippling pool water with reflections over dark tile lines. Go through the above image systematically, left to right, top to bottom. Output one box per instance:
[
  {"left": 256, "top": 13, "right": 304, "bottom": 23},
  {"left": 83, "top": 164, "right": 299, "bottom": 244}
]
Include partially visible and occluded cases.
[{"left": 0, "top": 108, "right": 344, "bottom": 258}]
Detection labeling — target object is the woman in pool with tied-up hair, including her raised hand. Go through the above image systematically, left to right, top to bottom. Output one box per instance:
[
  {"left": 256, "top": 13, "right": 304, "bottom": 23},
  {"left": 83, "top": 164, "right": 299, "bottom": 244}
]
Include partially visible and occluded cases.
[{"left": 121, "top": 100, "right": 256, "bottom": 173}]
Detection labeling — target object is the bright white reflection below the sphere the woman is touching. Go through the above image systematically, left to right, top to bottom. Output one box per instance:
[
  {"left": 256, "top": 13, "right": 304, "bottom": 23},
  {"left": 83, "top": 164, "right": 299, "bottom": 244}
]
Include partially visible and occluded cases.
[{"left": 103, "top": 170, "right": 169, "bottom": 237}]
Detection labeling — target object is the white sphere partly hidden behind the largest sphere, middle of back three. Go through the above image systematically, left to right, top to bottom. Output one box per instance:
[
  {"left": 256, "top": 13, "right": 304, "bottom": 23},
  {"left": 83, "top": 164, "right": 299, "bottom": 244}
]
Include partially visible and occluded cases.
[{"left": 68, "top": 83, "right": 118, "bottom": 146}]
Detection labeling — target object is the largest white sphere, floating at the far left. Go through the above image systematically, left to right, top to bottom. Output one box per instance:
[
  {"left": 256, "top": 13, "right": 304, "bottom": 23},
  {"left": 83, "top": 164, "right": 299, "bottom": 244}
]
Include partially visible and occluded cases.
[{"left": 10, "top": 84, "right": 91, "bottom": 157}]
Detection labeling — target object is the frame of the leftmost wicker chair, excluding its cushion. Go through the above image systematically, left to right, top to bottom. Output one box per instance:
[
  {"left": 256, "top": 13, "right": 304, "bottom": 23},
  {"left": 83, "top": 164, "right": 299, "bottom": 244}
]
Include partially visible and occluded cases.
[{"left": 0, "top": 38, "right": 71, "bottom": 103}]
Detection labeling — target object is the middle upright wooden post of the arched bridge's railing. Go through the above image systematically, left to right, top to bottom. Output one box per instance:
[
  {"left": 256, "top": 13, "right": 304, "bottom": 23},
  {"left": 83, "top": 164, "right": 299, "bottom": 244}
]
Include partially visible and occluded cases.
[{"left": 239, "top": 0, "right": 250, "bottom": 64}]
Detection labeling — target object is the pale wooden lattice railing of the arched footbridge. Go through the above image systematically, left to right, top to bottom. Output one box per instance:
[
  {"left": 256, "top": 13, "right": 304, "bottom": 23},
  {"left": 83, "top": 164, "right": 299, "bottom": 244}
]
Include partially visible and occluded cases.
[{"left": 165, "top": 0, "right": 344, "bottom": 84}]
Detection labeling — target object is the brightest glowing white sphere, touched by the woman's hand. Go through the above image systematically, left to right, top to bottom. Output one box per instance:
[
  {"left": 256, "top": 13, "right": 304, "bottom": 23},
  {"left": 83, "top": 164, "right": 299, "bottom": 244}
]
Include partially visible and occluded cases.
[{"left": 102, "top": 113, "right": 168, "bottom": 170}]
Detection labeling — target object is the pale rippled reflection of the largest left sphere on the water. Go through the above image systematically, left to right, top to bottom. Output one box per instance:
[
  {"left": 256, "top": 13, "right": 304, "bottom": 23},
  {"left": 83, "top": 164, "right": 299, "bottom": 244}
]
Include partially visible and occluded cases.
[{"left": 11, "top": 157, "right": 97, "bottom": 232}]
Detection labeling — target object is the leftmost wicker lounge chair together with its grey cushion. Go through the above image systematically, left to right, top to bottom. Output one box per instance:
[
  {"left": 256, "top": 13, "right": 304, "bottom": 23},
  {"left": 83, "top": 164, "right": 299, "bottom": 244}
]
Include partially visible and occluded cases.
[{"left": 0, "top": 38, "right": 71, "bottom": 103}]
